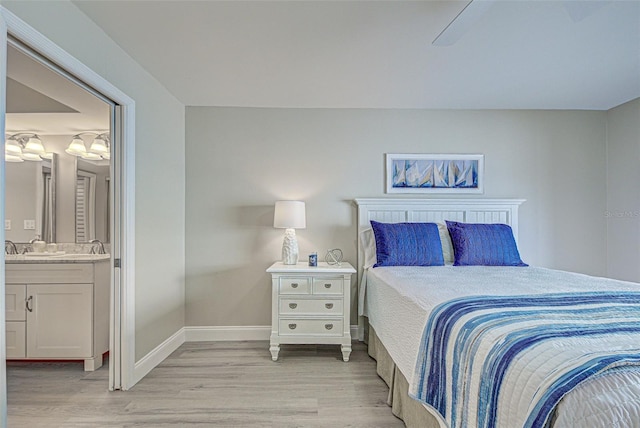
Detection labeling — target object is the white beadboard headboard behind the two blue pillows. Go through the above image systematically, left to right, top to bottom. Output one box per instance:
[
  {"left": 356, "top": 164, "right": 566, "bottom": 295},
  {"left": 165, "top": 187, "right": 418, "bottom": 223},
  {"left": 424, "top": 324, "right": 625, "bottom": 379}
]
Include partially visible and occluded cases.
[{"left": 355, "top": 198, "right": 525, "bottom": 274}]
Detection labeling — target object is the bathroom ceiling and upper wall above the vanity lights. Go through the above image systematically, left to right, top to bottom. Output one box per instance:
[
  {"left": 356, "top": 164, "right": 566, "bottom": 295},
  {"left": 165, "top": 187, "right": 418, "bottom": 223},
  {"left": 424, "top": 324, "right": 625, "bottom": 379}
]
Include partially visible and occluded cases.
[{"left": 5, "top": 46, "right": 110, "bottom": 135}]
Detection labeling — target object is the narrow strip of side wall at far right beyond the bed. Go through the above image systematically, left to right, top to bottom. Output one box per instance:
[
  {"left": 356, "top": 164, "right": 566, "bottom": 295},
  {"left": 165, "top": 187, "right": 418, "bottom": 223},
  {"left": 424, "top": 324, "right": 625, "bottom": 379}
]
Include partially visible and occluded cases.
[{"left": 605, "top": 98, "right": 640, "bottom": 282}]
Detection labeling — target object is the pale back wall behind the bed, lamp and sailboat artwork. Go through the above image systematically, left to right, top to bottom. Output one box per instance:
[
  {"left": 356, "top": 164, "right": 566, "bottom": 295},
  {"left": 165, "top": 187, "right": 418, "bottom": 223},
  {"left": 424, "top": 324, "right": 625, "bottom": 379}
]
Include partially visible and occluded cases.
[{"left": 186, "top": 107, "right": 606, "bottom": 326}]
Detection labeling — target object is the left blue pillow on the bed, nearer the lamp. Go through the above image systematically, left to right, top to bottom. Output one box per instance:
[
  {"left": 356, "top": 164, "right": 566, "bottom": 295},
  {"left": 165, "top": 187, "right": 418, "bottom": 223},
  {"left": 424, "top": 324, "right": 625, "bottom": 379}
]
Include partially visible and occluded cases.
[{"left": 371, "top": 221, "right": 444, "bottom": 267}]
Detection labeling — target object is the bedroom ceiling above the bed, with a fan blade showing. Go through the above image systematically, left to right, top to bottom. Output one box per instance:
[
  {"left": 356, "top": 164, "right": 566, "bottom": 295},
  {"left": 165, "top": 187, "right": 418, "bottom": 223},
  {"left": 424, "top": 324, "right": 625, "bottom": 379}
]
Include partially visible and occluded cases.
[{"left": 74, "top": 0, "right": 640, "bottom": 110}]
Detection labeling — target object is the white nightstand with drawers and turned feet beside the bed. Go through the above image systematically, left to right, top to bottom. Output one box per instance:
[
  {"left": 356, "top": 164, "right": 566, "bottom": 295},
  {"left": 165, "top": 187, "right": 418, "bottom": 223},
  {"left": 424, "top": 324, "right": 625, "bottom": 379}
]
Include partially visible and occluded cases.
[{"left": 267, "top": 262, "right": 356, "bottom": 361}]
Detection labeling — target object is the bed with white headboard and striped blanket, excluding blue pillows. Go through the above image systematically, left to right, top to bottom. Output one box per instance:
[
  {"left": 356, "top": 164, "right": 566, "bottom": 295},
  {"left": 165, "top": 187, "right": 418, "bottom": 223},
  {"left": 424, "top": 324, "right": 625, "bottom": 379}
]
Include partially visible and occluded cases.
[{"left": 356, "top": 199, "right": 640, "bottom": 428}]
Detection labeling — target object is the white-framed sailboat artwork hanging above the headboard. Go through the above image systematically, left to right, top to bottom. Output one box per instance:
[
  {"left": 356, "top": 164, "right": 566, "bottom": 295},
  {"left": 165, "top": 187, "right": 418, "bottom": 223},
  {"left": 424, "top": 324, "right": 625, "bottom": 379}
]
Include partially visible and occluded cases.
[{"left": 386, "top": 153, "right": 484, "bottom": 194}]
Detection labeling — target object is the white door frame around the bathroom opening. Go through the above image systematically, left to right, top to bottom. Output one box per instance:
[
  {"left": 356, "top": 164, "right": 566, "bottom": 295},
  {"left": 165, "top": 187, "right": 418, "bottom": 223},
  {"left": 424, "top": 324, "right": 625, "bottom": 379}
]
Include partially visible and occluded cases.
[{"left": 0, "top": 6, "right": 135, "bottom": 425}]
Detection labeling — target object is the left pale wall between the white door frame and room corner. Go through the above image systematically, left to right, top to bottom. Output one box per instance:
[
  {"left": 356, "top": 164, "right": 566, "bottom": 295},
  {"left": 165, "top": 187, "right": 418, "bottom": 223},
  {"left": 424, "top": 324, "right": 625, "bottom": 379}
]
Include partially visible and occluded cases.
[{"left": 2, "top": 0, "right": 185, "bottom": 359}]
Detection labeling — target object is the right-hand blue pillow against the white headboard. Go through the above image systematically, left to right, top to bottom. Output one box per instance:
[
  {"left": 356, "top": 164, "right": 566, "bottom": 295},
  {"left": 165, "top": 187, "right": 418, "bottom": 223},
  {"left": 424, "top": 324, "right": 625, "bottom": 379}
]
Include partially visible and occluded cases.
[{"left": 447, "top": 221, "right": 528, "bottom": 266}]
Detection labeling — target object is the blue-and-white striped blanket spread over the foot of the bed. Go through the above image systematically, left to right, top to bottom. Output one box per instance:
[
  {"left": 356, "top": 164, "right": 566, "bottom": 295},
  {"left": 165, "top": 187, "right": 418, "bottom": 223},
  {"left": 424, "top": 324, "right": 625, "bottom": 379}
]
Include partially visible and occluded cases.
[{"left": 410, "top": 292, "right": 640, "bottom": 428}]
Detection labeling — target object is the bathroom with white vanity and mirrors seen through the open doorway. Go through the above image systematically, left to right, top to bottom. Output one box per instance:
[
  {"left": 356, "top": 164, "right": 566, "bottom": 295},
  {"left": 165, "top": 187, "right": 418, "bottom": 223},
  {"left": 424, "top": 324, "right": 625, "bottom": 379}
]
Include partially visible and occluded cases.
[{"left": 5, "top": 38, "right": 115, "bottom": 372}]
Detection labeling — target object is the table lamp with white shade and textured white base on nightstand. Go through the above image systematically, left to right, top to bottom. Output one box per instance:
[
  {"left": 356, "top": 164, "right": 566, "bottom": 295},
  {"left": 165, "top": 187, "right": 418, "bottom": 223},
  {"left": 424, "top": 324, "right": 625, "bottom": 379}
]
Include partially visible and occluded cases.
[{"left": 273, "top": 201, "right": 307, "bottom": 265}]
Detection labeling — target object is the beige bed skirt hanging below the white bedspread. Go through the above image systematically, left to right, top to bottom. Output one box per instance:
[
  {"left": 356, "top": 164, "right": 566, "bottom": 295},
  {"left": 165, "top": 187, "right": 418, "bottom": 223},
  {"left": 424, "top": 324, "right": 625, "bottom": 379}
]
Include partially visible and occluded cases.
[{"left": 368, "top": 325, "right": 440, "bottom": 428}]
